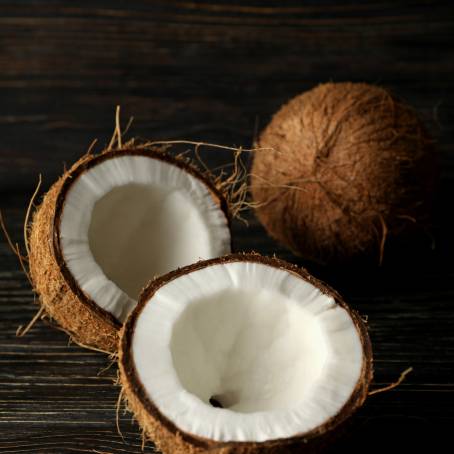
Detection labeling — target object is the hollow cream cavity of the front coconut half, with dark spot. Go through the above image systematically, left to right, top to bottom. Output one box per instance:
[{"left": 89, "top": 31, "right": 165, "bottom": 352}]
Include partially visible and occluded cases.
[{"left": 170, "top": 288, "right": 330, "bottom": 413}]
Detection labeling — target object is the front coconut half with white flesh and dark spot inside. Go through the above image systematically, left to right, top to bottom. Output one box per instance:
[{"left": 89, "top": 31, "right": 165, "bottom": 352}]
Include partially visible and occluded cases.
[{"left": 119, "top": 254, "right": 372, "bottom": 454}]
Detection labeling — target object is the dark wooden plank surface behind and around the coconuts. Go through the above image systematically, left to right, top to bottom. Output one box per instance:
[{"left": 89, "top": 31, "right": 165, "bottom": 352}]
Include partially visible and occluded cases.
[{"left": 0, "top": 0, "right": 454, "bottom": 454}]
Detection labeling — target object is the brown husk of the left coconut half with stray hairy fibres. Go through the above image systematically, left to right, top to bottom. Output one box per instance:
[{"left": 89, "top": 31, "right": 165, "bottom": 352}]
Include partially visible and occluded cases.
[{"left": 1, "top": 108, "right": 255, "bottom": 353}]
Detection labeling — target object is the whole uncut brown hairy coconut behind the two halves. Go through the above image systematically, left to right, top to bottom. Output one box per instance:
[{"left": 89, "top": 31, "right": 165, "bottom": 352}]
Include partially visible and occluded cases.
[{"left": 251, "top": 83, "right": 436, "bottom": 263}]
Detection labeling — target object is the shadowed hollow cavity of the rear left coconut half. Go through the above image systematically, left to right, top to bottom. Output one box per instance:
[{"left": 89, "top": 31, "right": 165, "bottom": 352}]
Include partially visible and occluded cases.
[{"left": 89, "top": 183, "right": 215, "bottom": 300}]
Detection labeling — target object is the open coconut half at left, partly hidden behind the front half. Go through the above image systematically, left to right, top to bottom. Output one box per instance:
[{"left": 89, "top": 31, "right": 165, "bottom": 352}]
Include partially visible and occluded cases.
[{"left": 29, "top": 149, "right": 231, "bottom": 351}]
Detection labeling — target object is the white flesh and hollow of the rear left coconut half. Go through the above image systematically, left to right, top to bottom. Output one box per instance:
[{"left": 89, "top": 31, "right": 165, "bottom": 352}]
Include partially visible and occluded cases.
[{"left": 60, "top": 155, "right": 230, "bottom": 322}]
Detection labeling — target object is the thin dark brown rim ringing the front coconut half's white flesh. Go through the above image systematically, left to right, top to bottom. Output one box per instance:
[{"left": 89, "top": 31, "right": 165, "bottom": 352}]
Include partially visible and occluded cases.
[{"left": 119, "top": 253, "right": 373, "bottom": 448}]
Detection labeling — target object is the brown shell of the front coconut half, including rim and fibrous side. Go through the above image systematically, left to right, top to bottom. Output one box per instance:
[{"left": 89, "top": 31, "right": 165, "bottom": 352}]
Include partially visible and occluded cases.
[{"left": 119, "top": 253, "right": 373, "bottom": 454}]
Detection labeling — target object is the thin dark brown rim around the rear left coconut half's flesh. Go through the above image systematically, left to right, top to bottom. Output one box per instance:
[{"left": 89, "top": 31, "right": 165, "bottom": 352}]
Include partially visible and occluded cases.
[{"left": 52, "top": 148, "right": 232, "bottom": 330}]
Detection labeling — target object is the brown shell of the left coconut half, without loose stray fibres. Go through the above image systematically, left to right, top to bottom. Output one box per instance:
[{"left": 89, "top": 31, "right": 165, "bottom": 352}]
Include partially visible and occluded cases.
[{"left": 28, "top": 148, "right": 230, "bottom": 352}]
